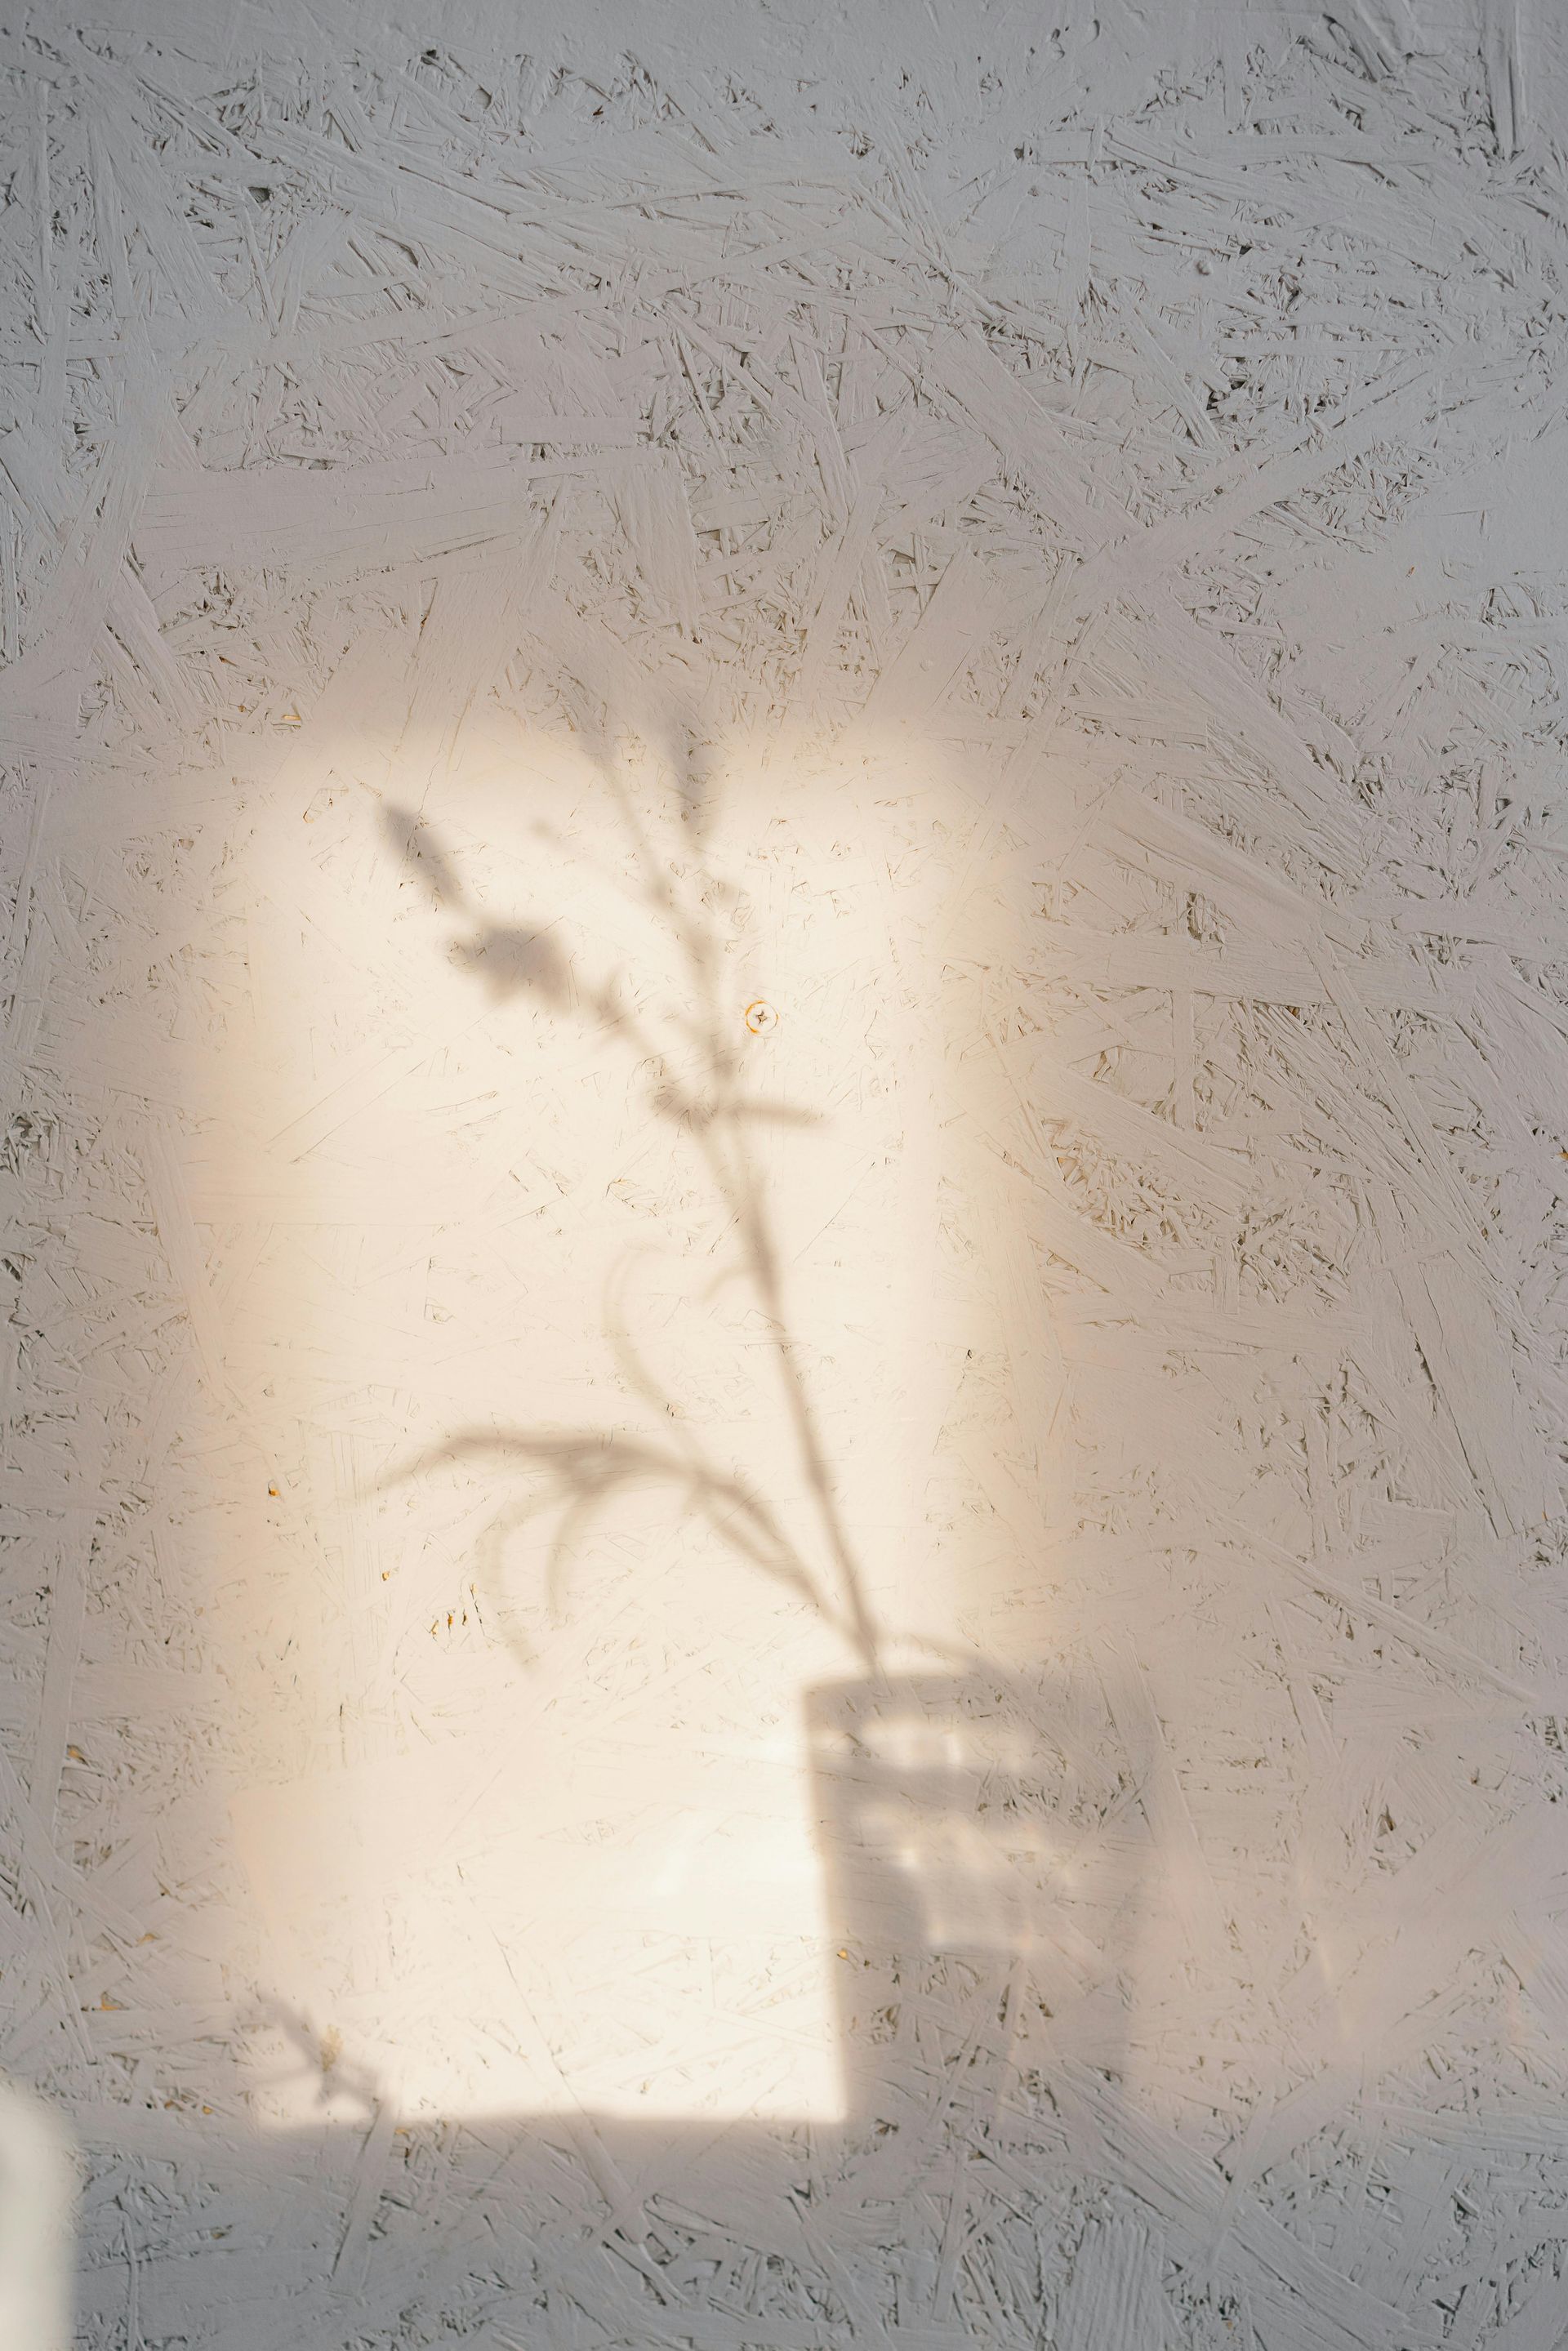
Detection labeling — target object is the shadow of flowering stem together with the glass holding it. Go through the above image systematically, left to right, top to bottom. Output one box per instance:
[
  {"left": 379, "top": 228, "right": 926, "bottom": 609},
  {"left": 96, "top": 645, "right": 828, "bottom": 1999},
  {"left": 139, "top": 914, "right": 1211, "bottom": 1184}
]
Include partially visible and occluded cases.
[{"left": 364, "top": 759, "right": 1143, "bottom": 2196}]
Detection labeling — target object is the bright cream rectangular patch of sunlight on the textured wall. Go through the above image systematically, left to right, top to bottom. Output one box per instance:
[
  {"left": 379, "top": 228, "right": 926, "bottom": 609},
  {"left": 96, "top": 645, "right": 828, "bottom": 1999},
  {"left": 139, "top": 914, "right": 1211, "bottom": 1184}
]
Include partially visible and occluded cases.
[{"left": 207, "top": 717, "right": 1034, "bottom": 2123}]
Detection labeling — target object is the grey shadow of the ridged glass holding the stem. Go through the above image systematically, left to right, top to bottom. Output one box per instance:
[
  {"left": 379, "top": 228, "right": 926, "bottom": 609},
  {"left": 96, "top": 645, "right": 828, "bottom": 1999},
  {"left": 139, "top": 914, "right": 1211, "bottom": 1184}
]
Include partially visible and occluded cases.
[{"left": 806, "top": 1667, "right": 1140, "bottom": 2137}]
